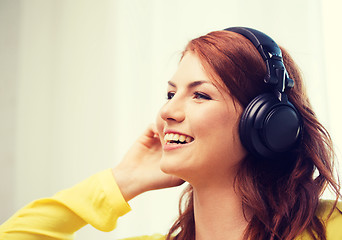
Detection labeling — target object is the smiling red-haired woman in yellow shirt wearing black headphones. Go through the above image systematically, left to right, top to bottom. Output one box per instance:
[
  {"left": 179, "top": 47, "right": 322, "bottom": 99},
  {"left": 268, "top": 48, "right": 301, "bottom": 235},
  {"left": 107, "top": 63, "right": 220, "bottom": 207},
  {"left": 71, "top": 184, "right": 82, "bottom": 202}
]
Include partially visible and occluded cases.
[{"left": 0, "top": 28, "right": 342, "bottom": 240}]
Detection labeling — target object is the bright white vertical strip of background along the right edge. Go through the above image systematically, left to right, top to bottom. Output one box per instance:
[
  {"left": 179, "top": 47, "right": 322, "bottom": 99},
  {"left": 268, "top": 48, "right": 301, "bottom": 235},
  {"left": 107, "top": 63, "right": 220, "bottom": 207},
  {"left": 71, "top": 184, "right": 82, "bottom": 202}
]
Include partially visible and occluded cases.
[{"left": 322, "top": 0, "right": 342, "bottom": 173}]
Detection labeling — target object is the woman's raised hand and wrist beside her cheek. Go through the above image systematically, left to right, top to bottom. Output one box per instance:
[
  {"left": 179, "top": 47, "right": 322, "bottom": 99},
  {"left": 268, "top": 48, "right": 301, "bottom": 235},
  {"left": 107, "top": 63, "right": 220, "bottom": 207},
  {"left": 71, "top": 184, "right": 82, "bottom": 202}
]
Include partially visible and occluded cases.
[{"left": 113, "top": 124, "right": 184, "bottom": 201}]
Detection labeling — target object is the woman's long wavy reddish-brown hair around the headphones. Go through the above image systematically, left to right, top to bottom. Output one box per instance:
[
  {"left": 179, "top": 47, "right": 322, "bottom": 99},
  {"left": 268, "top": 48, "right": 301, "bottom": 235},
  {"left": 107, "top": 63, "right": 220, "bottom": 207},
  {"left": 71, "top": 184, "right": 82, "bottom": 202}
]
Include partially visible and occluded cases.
[{"left": 166, "top": 31, "right": 341, "bottom": 240}]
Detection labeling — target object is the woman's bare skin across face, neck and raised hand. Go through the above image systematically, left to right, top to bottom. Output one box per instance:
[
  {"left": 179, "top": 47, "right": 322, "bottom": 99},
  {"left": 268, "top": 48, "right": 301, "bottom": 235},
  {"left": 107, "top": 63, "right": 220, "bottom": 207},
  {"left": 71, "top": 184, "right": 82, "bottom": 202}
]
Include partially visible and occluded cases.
[{"left": 113, "top": 53, "right": 247, "bottom": 240}]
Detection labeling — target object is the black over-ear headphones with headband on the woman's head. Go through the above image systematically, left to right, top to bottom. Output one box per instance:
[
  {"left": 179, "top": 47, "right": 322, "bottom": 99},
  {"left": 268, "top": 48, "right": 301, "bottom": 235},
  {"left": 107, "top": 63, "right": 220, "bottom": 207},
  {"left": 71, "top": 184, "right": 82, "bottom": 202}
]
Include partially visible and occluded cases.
[{"left": 224, "top": 27, "right": 302, "bottom": 159}]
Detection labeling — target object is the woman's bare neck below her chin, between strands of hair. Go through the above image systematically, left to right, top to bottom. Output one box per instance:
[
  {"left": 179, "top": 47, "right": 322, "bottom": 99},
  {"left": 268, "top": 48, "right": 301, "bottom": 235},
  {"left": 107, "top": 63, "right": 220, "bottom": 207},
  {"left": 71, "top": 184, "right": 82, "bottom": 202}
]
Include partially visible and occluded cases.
[{"left": 194, "top": 181, "right": 248, "bottom": 240}]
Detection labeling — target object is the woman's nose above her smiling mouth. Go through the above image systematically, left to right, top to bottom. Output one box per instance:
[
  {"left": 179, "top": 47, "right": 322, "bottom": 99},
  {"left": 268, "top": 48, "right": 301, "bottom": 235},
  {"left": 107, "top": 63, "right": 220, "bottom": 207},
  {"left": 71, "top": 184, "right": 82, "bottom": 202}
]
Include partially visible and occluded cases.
[{"left": 160, "top": 97, "right": 185, "bottom": 123}]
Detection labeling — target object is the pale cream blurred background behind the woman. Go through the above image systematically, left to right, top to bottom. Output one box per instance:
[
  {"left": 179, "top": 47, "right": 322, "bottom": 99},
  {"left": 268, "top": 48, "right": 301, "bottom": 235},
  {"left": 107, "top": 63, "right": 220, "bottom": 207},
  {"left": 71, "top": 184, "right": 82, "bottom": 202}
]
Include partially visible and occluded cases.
[{"left": 0, "top": 0, "right": 342, "bottom": 240}]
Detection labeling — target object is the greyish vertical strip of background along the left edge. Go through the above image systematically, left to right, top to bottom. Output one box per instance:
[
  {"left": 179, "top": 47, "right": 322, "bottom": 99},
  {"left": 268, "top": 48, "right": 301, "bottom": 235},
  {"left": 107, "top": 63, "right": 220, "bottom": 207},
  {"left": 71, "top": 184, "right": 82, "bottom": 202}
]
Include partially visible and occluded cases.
[{"left": 0, "top": 0, "right": 19, "bottom": 225}]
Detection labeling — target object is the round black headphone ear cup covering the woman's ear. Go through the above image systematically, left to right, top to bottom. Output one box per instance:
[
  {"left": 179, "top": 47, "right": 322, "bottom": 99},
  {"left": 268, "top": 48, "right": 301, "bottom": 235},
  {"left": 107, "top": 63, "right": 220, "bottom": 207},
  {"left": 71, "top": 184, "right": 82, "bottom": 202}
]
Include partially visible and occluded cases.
[{"left": 239, "top": 93, "right": 301, "bottom": 159}]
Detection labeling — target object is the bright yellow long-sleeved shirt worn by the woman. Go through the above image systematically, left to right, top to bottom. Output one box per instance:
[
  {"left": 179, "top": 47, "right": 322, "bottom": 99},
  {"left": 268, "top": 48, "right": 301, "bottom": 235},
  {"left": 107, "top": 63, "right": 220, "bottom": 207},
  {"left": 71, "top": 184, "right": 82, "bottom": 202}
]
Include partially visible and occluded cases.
[{"left": 0, "top": 169, "right": 342, "bottom": 240}]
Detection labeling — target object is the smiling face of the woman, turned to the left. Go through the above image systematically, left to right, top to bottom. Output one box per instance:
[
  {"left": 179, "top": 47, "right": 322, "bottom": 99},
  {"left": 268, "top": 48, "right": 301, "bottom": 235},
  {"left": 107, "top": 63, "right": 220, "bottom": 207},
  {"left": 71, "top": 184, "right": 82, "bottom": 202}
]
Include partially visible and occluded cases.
[{"left": 157, "top": 53, "right": 246, "bottom": 184}]
